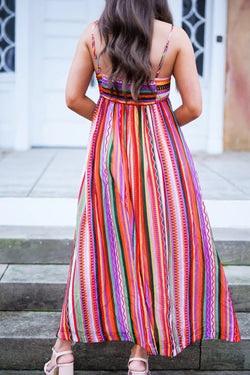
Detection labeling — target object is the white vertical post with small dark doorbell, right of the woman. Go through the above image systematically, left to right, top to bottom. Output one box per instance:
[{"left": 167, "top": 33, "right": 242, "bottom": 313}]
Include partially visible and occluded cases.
[{"left": 207, "top": 0, "right": 227, "bottom": 153}]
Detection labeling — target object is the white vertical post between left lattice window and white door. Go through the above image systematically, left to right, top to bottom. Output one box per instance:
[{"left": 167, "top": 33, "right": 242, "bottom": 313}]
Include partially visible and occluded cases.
[{"left": 14, "top": 0, "right": 32, "bottom": 150}]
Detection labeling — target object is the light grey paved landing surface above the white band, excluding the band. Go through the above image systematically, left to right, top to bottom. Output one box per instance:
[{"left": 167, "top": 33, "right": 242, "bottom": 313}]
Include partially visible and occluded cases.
[{"left": 0, "top": 148, "right": 250, "bottom": 200}]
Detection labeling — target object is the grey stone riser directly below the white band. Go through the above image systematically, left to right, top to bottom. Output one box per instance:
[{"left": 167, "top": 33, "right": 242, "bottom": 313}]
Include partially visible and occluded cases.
[{"left": 0, "top": 236, "right": 250, "bottom": 265}]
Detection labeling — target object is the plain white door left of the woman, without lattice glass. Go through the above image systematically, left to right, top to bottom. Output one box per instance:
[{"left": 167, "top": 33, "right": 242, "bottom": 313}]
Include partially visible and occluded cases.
[{"left": 30, "top": 0, "right": 104, "bottom": 147}]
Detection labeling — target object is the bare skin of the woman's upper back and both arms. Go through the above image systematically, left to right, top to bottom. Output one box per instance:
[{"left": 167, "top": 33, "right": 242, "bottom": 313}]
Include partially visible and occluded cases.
[{"left": 66, "top": 16, "right": 202, "bottom": 125}]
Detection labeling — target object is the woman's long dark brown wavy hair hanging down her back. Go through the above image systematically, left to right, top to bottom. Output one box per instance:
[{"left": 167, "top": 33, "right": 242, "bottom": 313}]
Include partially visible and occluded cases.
[{"left": 98, "top": 0, "right": 173, "bottom": 100}]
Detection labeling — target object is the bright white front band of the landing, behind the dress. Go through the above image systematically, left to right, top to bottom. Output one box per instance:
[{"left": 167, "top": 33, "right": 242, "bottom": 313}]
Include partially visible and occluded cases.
[{"left": 0, "top": 197, "right": 250, "bottom": 228}]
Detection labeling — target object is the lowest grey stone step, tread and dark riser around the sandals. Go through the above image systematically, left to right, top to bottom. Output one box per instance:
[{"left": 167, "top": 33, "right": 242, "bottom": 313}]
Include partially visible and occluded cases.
[{"left": 0, "top": 311, "right": 250, "bottom": 374}]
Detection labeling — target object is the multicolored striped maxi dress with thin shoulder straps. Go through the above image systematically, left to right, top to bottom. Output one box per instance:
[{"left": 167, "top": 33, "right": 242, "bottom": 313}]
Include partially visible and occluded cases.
[{"left": 56, "top": 21, "right": 241, "bottom": 357}]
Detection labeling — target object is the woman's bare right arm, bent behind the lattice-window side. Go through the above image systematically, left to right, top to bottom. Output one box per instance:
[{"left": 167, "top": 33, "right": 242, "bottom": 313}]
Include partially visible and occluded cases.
[{"left": 173, "top": 28, "right": 202, "bottom": 126}]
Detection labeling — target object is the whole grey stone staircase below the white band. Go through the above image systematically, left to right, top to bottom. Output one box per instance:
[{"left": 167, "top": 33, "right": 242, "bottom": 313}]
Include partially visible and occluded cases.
[{"left": 0, "top": 228, "right": 250, "bottom": 375}]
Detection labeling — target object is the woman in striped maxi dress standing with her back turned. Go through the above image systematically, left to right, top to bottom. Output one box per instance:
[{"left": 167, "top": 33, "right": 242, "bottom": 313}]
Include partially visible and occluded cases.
[{"left": 44, "top": 0, "right": 241, "bottom": 375}]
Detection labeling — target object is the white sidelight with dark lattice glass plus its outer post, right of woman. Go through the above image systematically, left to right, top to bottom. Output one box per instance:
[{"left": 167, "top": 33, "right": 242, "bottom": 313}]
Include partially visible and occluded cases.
[{"left": 169, "top": 0, "right": 227, "bottom": 153}]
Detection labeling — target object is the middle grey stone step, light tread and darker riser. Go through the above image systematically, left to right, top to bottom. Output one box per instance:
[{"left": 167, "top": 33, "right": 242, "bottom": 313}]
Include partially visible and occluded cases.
[{"left": 0, "top": 264, "right": 250, "bottom": 311}]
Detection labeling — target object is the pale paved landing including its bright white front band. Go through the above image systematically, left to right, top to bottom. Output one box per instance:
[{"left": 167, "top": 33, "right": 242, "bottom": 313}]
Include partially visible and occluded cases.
[{"left": 0, "top": 148, "right": 250, "bottom": 228}]
